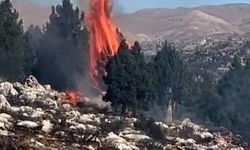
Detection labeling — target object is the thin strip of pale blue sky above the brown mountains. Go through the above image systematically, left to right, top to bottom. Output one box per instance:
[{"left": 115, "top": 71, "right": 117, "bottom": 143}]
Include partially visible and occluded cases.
[{"left": 13, "top": 0, "right": 250, "bottom": 12}]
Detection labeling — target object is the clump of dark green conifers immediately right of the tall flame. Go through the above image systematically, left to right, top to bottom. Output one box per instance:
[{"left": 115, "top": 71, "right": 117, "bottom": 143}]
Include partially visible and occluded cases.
[{"left": 104, "top": 41, "right": 193, "bottom": 117}]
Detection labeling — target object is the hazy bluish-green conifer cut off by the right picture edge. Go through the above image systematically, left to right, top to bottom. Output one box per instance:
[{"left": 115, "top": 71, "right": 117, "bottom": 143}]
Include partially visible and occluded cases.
[{"left": 217, "top": 57, "right": 250, "bottom": 139}]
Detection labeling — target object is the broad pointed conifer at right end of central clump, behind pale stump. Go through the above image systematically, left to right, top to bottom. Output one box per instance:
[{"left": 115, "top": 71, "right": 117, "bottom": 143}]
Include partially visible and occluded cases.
[{"left": 152, "top": 42, "right": 193, "bottom": 106}]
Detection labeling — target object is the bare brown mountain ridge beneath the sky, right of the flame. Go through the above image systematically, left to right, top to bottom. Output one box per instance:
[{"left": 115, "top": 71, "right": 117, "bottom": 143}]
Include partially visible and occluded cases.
[{"left": 115, "top": 4, "right": 250, "bottom": 40}]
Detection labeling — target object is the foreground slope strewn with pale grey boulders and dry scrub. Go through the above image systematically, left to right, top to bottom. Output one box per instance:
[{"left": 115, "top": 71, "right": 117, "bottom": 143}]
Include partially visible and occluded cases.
[{"left": 0, "top": 76, "right": 248, "bottom": 150}]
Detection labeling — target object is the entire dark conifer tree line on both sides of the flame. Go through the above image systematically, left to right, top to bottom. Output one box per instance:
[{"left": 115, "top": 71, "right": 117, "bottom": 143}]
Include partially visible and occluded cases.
[{"left": 0, "top": 0, "right": 250, "bottom": 142}]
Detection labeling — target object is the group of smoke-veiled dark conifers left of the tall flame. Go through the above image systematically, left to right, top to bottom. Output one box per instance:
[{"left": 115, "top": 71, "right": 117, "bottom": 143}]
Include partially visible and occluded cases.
[{"left": 0, "top": 0, "right": 88, "bottom": 90}]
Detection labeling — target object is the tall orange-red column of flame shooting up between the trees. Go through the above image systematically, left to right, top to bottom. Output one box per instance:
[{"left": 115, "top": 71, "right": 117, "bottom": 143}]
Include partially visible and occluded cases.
[{"left": 87, "top": 0, "right": 119, "bottom": 87}]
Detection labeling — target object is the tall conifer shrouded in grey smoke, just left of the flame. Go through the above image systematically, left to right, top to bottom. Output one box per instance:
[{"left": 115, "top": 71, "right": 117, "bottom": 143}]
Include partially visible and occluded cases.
[{"left": 33, "top": 0, "right": 88, "bottom": 90}]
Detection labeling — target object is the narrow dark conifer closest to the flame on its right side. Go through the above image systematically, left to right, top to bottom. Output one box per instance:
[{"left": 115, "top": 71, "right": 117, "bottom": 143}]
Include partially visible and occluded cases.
[{"left": 104, "top": 41, "right": 136, "bottom": 114}]
